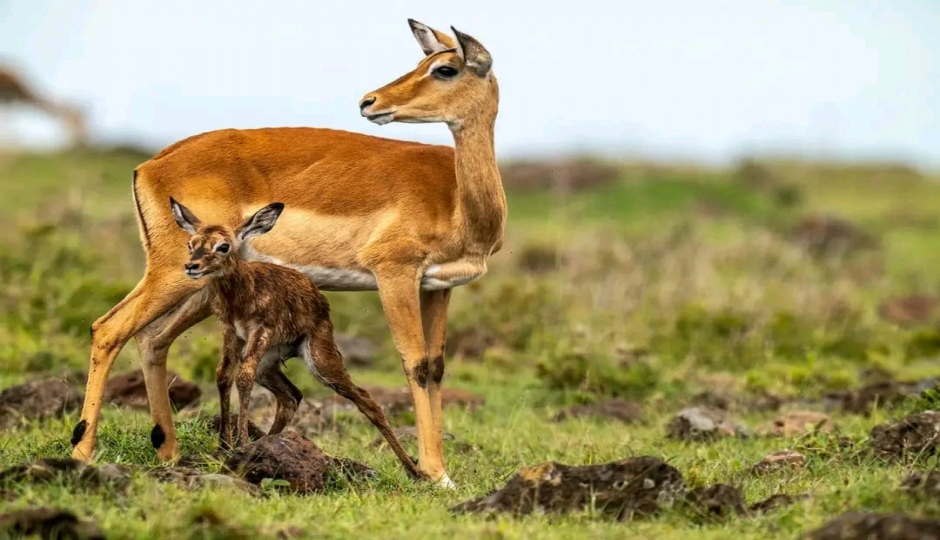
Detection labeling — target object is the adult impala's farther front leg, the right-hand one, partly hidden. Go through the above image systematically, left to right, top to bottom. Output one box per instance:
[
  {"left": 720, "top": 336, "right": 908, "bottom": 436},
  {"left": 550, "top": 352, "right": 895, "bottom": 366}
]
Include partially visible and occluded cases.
[{"left": 421, "top": 289, "right": 456, "bottom": 488}]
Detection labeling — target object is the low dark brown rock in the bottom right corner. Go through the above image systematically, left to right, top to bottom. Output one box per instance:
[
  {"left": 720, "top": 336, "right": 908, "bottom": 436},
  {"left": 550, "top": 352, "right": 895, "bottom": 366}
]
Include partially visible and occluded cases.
[{"left": 802, "top": 512, "right": 940, "bottom": 540}]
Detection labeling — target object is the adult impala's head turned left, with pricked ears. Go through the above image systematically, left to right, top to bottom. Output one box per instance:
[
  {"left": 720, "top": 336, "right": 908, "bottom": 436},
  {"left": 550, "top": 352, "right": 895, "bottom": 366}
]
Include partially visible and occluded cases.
[{"left": 359, "top": 19, "right": 499, "bottom": 127}]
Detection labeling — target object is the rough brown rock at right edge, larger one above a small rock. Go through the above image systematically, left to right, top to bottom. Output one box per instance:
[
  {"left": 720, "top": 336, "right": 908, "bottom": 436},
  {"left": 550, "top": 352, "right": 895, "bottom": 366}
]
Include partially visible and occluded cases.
[{"left": 870, "top": 411, "right": 940, "bottom": 460}]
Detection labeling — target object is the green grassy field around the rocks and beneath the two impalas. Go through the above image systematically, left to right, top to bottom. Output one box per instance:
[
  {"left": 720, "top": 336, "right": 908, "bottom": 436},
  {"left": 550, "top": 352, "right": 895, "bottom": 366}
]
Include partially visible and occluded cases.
[{"left": 0, "top": 148, "right": 940, "bottom": 539}]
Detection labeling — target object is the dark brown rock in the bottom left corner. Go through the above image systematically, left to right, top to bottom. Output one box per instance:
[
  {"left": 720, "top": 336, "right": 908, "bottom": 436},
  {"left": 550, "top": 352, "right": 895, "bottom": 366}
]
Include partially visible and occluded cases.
[{"left": 0, "top": 508, "right": 105, "bottom": 540}]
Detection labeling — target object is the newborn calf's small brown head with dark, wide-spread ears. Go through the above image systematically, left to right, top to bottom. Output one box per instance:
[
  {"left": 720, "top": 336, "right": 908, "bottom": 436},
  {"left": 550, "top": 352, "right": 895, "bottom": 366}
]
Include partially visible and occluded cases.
[{"left": 170, "top": 197, "right": 284, "bottom": 279}]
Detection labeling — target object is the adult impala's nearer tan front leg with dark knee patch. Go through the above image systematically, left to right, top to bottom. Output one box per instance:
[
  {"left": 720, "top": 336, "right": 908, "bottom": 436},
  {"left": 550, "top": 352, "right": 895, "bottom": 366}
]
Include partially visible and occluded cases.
[{"left": 376, "top": 267, "right": 452, "bottom": 487}]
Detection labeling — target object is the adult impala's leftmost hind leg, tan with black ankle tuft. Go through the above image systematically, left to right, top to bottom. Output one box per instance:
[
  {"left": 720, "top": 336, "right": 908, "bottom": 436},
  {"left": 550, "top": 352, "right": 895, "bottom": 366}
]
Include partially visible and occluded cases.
[{"left": 72, "top": 272, "right": 202, "bottom": 461}]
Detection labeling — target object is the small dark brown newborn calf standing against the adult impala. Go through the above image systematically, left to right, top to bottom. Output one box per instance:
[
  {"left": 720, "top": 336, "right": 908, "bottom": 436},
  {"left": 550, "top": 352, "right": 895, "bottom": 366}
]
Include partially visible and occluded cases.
[{"left": 170, "top": 197, "right": 421, "bottom": 478}]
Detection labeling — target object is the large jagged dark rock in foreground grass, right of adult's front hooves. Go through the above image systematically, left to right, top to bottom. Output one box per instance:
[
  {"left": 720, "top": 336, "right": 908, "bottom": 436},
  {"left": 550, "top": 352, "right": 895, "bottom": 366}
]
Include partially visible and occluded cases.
[{"left": 451, "top": 456, "right": 685, "bottom": 520}]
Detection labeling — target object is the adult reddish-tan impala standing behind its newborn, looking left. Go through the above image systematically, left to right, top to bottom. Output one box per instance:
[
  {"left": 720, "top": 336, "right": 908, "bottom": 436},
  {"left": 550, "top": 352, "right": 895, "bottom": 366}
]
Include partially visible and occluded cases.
[{"left": 72, "top": 19, "right": 506, "bottom": 486}]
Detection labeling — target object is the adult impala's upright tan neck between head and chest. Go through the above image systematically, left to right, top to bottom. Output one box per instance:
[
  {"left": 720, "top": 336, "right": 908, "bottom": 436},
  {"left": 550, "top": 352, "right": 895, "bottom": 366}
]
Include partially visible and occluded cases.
[{"left": 450, "top": 110, "right": 506, "bottom": 249}]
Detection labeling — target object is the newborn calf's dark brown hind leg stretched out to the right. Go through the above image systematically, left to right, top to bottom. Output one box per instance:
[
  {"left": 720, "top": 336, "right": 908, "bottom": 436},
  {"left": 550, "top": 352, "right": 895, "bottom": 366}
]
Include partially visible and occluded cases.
[{"left": 301, "top": 320, "right": 425, "bottom": 479}]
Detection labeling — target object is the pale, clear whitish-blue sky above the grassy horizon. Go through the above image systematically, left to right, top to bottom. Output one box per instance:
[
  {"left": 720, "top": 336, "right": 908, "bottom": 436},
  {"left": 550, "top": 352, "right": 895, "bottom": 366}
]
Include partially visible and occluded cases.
[{"left": 0, "top": 0, "right": 940, "bottom": 167}]
